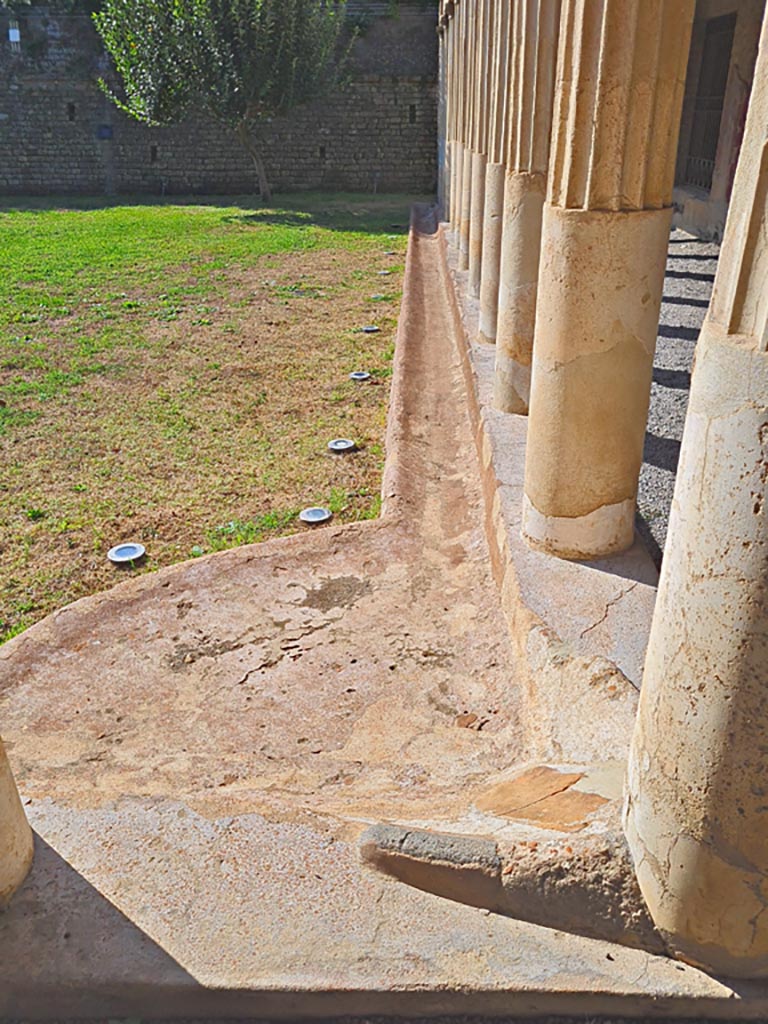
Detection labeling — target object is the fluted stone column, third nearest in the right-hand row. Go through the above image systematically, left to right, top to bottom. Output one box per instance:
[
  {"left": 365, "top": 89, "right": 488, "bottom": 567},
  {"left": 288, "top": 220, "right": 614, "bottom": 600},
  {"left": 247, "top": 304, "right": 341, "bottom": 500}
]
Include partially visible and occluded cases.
[{"left": 494, "top": 0, "right": 560, "bottom": 403}]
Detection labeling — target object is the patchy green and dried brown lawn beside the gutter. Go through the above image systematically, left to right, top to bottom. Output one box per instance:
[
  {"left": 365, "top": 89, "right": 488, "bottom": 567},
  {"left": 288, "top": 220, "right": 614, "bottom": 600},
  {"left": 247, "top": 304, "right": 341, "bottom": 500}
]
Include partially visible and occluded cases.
[{"left": 0, "top": 195, "right": 421, "bottom": 641}]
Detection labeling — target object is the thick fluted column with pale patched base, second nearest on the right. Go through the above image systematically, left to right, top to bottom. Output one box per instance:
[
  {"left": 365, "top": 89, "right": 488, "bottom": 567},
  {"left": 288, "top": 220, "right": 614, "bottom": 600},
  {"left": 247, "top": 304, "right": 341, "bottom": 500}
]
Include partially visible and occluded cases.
[{"left": 523, "top": 0, "right": 694, "bottom": 558}]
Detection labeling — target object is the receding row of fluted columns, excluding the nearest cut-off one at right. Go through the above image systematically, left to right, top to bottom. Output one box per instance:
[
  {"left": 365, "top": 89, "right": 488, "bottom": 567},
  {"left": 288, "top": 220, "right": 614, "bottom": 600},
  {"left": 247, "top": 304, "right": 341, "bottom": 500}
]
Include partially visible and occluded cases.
[{"left": 442, "top": 0, "right": 694, "bottom": 558}]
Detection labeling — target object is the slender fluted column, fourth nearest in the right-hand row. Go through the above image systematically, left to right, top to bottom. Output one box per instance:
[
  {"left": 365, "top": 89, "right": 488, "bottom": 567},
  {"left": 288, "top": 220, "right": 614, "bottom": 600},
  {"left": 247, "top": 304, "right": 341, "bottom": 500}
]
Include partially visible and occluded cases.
[{"left": 479, "top": 0, "right": 515, "bottom": 344}]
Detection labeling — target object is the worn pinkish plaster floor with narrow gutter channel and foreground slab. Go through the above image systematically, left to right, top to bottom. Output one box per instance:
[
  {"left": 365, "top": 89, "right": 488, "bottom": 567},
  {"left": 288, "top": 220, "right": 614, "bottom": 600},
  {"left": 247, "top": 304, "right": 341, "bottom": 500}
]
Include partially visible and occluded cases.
[{"left": 0, "top": 211, "right": 768, "bottom": 1019}]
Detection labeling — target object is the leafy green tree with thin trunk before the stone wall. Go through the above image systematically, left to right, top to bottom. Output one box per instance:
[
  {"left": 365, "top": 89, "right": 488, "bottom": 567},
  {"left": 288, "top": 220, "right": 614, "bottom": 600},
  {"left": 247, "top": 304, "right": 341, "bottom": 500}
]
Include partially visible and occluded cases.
[{"left": 93, "top": 0, "right": 346, "bottom": 201}]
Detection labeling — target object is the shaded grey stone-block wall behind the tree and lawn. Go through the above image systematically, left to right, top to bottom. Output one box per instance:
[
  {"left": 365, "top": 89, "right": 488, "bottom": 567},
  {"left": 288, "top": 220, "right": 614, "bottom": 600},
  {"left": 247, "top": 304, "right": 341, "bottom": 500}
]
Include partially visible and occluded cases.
[{"left": 0, "top": 5, "right": 436, "bottom": 195}]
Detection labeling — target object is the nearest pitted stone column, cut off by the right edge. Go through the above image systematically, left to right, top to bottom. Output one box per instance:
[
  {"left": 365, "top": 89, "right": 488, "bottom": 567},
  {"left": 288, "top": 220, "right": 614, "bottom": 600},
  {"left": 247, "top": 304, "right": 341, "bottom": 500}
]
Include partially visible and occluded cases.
[{"left": 625, "top": 12, "right": 768, "bottom": 977}]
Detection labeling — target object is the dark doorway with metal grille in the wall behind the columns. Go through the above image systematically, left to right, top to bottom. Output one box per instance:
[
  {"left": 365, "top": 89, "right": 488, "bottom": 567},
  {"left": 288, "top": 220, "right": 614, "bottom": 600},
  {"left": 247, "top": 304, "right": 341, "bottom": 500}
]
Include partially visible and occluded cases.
[{"left": 685, "top": 14, "right": 736, "bottom": 191}]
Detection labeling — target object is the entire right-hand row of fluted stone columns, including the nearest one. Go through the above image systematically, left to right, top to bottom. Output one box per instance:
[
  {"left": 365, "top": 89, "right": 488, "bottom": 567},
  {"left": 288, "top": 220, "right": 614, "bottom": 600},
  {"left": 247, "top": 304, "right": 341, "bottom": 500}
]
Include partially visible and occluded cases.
[{"left": 440, "top": 0, "right": 768, "bottom": 977}]
